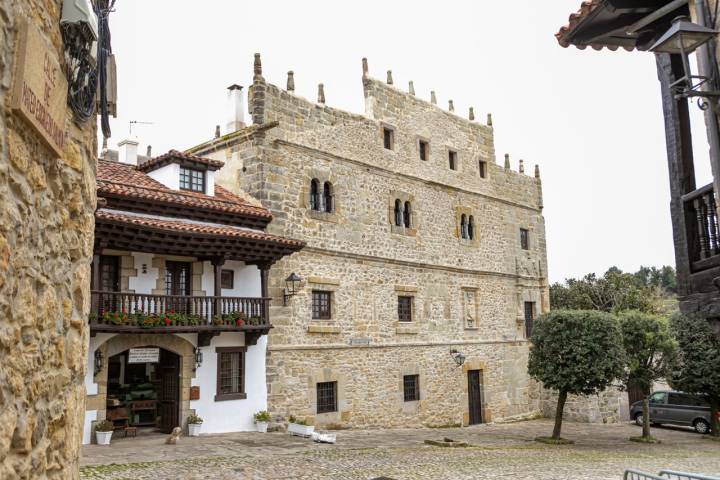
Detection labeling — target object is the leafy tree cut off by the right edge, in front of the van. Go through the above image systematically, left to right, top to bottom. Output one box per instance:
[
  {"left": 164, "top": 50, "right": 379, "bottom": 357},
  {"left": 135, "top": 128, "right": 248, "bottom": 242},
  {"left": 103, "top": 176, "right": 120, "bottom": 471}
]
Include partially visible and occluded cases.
[{"left": 669, "top": 315, "right": 720, "bottom": 437}]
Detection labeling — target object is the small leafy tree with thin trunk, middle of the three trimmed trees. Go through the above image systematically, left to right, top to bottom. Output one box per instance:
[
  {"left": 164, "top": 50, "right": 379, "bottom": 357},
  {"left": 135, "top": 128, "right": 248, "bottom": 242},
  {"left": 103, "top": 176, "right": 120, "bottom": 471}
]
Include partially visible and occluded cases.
[{"left": 620, "top": 311, "right": 676, "bottom": 440}]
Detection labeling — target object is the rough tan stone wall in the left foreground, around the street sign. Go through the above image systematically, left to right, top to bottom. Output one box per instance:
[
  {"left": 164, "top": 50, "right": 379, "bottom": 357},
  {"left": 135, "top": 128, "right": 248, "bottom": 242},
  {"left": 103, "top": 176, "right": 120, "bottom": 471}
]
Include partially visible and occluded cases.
[{"left": 0, "top": 0, "right": 96, "bottom": 479}]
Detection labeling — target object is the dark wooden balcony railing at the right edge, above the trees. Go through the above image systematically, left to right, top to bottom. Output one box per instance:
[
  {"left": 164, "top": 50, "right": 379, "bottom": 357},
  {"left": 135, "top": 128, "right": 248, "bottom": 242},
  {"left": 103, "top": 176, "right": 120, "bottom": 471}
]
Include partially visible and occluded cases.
[{"left": 682, "top": 183, "right": 720, "bottom": 271}]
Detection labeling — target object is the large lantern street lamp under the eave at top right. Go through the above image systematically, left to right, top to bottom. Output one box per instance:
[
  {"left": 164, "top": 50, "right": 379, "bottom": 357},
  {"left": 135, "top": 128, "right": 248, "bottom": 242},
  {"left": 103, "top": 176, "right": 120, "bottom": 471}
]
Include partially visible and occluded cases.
[{"left": 650, "top": 17, "right": 720, "bottom": 104}]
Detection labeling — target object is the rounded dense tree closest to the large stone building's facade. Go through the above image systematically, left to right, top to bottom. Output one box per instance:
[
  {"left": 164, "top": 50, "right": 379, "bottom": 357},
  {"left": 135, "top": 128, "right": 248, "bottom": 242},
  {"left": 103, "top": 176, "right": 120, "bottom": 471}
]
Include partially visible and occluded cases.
[{"left": 528, "top": 310, "right": 624, "bottom": 441}]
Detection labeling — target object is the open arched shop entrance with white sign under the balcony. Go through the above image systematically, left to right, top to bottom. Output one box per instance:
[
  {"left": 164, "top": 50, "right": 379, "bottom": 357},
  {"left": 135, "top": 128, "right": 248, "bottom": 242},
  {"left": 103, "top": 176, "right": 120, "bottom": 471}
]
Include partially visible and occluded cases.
[{"left": 106, "top": 347, "right": 180, "bottom": 433}]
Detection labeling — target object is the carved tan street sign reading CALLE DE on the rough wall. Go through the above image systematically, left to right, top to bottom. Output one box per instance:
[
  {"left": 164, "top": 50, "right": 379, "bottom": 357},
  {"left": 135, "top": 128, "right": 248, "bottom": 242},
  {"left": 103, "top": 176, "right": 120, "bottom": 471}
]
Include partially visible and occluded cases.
[{"left": 10, "top": 21, "right": 68, "bottom": 157}]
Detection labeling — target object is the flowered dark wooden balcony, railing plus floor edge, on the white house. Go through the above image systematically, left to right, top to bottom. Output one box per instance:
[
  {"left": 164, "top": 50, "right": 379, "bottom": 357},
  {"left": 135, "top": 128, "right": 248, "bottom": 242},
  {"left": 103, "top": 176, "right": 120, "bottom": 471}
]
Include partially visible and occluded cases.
[{"left": 89, "top": 290, "right": 272, "bottom": 346}]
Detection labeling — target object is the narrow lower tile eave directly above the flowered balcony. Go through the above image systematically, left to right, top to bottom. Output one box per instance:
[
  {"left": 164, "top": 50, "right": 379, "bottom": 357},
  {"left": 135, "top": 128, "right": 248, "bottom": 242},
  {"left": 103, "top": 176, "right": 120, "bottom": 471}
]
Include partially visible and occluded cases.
[{"left": 95, "top": 209, "right": 305, "bottom": 250}]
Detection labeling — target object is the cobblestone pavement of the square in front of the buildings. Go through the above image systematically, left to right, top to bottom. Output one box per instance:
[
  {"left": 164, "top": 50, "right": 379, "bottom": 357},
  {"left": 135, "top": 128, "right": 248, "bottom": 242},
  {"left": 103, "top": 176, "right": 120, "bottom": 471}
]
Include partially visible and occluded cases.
[{"left": 80, "top": 420, "right": 720, "bottom": 480}]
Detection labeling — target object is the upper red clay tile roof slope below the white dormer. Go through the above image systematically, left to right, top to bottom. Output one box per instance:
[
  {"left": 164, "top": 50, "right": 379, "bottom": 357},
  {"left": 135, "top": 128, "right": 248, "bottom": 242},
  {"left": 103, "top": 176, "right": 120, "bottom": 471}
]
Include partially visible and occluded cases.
[{"left": 97, "top": 159, "right": 272, "bottom": 221}]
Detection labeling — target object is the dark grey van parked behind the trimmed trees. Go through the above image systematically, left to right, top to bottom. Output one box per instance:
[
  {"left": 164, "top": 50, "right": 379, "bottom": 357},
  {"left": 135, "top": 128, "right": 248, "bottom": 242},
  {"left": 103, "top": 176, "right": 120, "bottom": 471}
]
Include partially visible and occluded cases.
[{"left": 630, "top": 390, "right": 710, "bottom": 433}]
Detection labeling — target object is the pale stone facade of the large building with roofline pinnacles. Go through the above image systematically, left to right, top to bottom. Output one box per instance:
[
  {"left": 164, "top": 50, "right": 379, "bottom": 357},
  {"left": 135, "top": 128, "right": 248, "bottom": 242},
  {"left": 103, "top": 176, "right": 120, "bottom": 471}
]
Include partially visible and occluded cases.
[{"left": 189, "top": 58, "right": 548, "bottom": 427}]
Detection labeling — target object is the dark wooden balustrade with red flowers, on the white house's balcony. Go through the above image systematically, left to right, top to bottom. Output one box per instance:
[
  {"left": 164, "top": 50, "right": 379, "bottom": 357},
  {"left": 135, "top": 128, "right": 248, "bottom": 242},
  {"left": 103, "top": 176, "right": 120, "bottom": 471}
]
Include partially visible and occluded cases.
[{"left": 90, "top": 290, "right": 270, "bottom": 328}]
